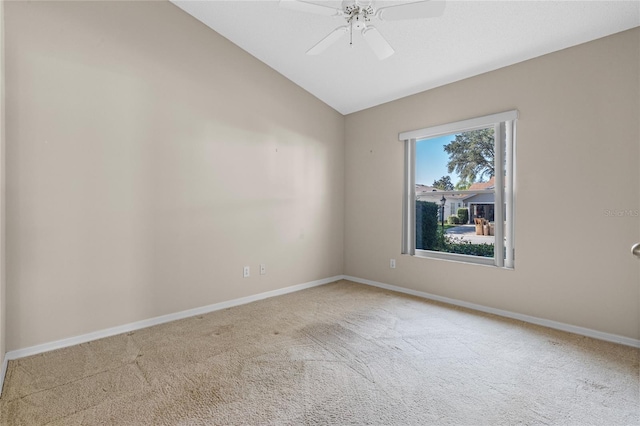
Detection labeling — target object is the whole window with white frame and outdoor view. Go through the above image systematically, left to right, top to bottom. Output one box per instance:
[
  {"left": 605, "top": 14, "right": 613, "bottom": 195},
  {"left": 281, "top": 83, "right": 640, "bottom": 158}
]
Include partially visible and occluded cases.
[{"left": 399, "top": 110, "right": 518, "bottom": 268}]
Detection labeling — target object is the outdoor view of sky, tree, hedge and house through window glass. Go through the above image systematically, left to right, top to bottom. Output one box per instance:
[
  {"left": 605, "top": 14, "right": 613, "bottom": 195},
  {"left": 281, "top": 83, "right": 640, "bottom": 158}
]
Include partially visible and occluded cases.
[{"left": 415, "top": 126, "right": 496, "bottom": 257}]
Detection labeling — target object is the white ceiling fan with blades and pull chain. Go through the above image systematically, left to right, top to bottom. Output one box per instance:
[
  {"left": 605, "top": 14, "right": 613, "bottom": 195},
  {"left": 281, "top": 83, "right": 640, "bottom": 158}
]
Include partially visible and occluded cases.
[{"left": 280, "top": 0, "right": 445, "bottom": 60}]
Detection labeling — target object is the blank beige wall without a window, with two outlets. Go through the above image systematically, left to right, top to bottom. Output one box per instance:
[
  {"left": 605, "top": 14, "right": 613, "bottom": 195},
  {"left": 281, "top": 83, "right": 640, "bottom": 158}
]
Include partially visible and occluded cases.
[{"left": 2, "top": 2, "right": 344, "bottom": 353}]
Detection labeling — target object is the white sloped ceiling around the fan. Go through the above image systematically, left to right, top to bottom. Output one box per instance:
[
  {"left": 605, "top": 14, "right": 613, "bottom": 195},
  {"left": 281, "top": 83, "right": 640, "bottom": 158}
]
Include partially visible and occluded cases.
[{"left": 172, "top": 0, "right": 640, "bottom": 114}]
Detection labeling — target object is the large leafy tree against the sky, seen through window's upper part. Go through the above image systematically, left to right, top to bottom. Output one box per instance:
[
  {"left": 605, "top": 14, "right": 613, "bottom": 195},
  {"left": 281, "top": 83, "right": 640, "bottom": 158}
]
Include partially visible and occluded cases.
[{"left": 444, "top": 128, "right": 495, "bottom": 182}]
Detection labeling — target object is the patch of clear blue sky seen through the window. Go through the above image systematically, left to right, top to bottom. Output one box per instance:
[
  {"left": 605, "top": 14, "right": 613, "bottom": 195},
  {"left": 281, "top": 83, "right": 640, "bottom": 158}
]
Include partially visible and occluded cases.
[{"left": 416, "top": 135, "right": 460, "bottom": 186}]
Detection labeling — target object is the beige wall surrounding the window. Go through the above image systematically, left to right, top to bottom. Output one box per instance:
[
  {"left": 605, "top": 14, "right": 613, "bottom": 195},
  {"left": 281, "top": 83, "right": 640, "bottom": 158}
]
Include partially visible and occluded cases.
[{"left": 345, "top": 29, "right": 640, "bottom": 339}]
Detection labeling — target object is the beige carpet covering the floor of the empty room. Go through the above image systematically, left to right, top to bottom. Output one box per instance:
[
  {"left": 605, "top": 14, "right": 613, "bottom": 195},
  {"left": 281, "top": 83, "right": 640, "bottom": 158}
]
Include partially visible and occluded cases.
[{"left": 0, "top": 281, "right": 640, "bottom": 426}]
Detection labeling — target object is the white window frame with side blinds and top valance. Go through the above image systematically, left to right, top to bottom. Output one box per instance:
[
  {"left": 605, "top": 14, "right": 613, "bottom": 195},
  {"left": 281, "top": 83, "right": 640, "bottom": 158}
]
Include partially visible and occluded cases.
[{"left": 398, "top": 110, "right": 518, "bottom": 269}]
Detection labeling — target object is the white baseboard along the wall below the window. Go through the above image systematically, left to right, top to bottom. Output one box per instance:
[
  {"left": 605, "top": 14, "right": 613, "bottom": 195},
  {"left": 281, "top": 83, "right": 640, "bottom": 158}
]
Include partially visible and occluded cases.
[{"left": 343, "top": 275, "right": 640, "bottom": 348}]
